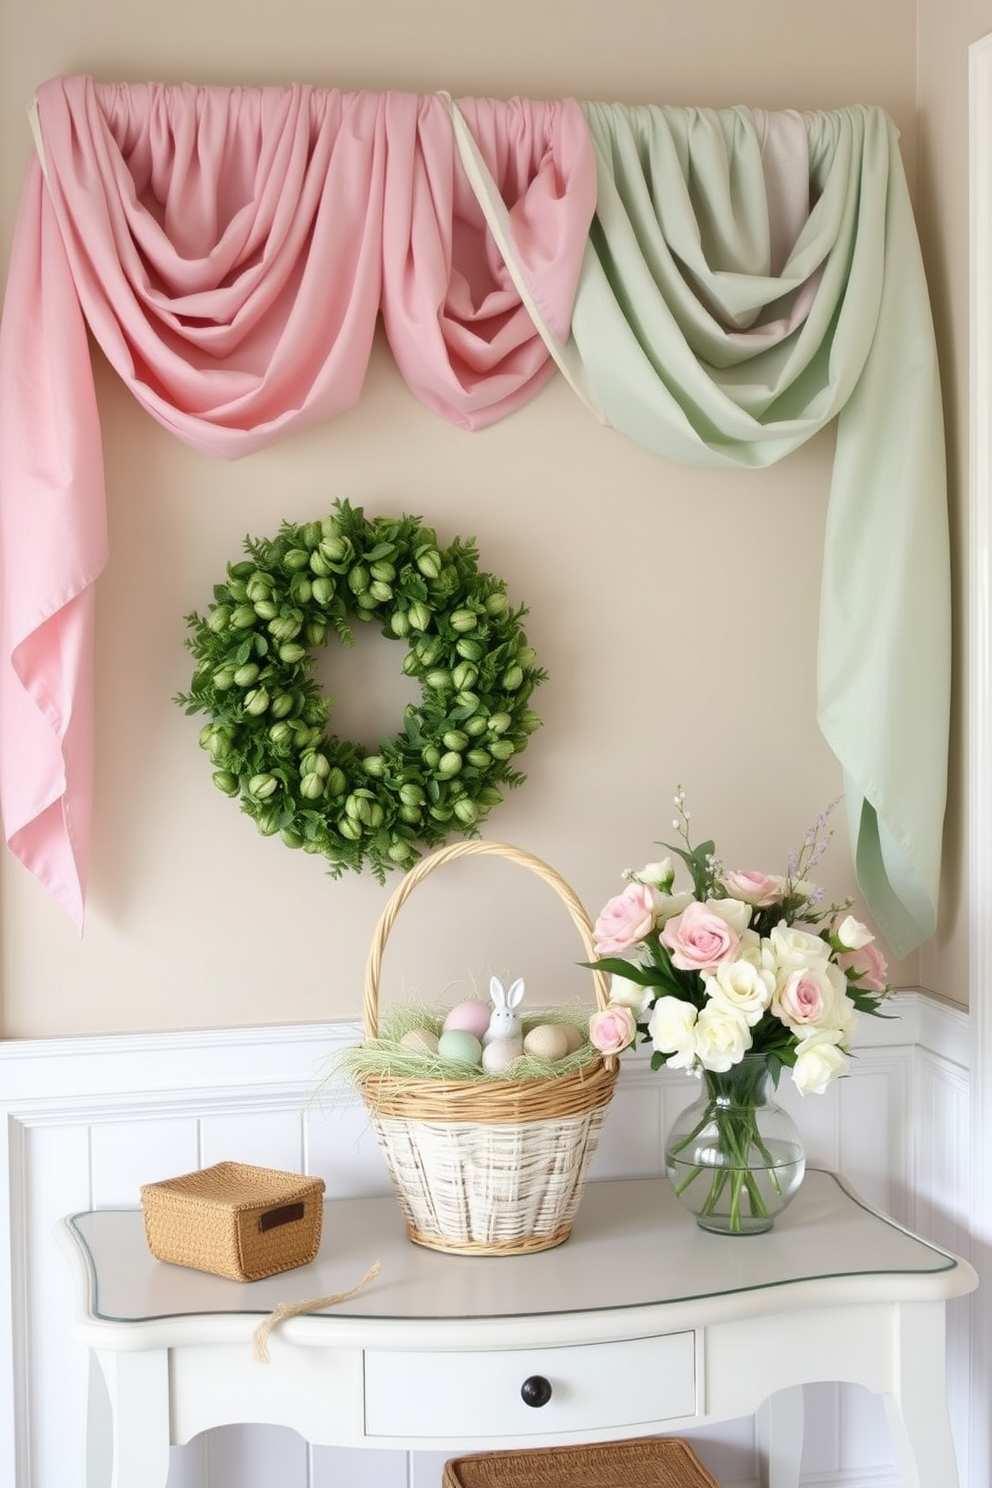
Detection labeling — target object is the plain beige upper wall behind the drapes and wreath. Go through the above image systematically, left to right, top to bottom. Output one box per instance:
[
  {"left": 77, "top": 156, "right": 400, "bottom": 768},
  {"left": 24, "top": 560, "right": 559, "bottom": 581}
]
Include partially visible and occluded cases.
[{"left": 0, "top": 0, "right": 969, "bottom": 1037}]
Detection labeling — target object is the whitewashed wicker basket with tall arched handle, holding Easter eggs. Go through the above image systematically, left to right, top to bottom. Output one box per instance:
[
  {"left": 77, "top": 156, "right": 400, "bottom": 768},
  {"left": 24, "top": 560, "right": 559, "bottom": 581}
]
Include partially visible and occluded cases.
[{"left": 357, "top": 838, "right": 617, "bottom": 1256}]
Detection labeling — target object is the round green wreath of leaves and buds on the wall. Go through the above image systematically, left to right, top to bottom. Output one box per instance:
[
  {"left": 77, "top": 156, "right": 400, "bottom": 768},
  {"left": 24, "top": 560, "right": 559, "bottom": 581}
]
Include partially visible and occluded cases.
[{"left": 174, "top": 501, "right": 547, "bottom": 882}]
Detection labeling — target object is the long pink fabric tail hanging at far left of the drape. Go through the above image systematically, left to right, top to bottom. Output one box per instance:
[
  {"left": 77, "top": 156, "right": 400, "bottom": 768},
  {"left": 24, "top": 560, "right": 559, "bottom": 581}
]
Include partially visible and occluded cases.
[{"left": 0, "top": 171, "right": 107, "bottom": 923}]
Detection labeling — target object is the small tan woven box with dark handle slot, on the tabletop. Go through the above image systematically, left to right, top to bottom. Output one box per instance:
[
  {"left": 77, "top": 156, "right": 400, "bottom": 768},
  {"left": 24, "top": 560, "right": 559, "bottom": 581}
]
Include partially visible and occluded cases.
[{"left": 141, "top": 1162, "right": 324, "bottom": 1281}]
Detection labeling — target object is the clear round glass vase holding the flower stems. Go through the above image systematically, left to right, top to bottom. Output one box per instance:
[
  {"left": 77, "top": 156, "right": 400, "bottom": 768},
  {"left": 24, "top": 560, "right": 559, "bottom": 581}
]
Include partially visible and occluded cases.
[{"left": 665, "top": 1054, "right": 806, "bottom": 1235}]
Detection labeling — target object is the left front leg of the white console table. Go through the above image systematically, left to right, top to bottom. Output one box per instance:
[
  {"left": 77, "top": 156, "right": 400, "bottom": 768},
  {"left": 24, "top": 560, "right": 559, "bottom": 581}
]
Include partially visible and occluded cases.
[{"left": 86, "top": 1348, "right": 170, "bottom": 1488}]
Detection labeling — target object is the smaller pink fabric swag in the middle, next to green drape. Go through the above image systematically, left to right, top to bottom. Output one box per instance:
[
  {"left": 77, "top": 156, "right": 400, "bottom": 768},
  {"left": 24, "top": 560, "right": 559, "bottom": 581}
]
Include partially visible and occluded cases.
[{"left": 382, "top": 94, "right": 595, "bottom": 429}]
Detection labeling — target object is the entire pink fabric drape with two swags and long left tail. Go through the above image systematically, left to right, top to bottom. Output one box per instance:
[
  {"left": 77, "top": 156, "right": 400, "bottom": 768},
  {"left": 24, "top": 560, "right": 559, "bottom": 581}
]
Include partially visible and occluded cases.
[{"left": 0, "top": 77, "right": 596, "bottom": 929}]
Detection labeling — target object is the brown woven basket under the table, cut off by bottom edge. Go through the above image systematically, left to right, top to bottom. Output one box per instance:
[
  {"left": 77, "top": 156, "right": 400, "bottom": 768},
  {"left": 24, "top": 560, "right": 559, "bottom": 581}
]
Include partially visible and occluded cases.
[{"left": 440, "top": 1436, "right": 720, "bottom": 1488}]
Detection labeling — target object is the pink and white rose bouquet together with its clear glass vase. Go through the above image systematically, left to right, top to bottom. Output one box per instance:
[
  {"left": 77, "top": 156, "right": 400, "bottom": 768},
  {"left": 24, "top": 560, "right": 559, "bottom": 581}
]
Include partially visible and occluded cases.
[{"left": 589, "top": 787, "right": 891, "bottom": 1234}]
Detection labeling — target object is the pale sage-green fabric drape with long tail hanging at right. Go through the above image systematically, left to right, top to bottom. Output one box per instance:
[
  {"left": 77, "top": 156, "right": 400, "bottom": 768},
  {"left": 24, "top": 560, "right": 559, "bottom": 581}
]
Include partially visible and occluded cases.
[{"left": 573, "top": 103, "right": 950, "bottom": 955}]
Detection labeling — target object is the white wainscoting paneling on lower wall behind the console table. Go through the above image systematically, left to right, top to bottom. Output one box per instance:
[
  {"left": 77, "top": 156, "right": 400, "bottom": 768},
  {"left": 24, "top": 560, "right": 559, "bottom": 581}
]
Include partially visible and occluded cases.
[{"left": 0, "top": 992, "right": 986, "bottom": 1488}]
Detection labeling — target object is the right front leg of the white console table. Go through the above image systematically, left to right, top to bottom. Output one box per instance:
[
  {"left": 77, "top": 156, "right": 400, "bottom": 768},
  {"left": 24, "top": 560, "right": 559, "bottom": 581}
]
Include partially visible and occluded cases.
[{"left": 883, "top": 1302, "right": 958, "bottom": 1488}]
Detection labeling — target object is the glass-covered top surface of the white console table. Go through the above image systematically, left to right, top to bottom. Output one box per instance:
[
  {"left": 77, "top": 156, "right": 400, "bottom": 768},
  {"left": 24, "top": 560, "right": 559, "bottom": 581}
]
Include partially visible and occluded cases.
[{"left": 67, "top": 1170, "right": 959, "bottom": 1323}]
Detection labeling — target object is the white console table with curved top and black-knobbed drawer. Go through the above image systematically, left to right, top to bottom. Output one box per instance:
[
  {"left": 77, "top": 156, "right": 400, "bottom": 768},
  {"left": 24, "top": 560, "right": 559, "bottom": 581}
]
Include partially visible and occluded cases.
[{"left": 61, "top": 1171, "right": 977, "bottom": 1488}]
